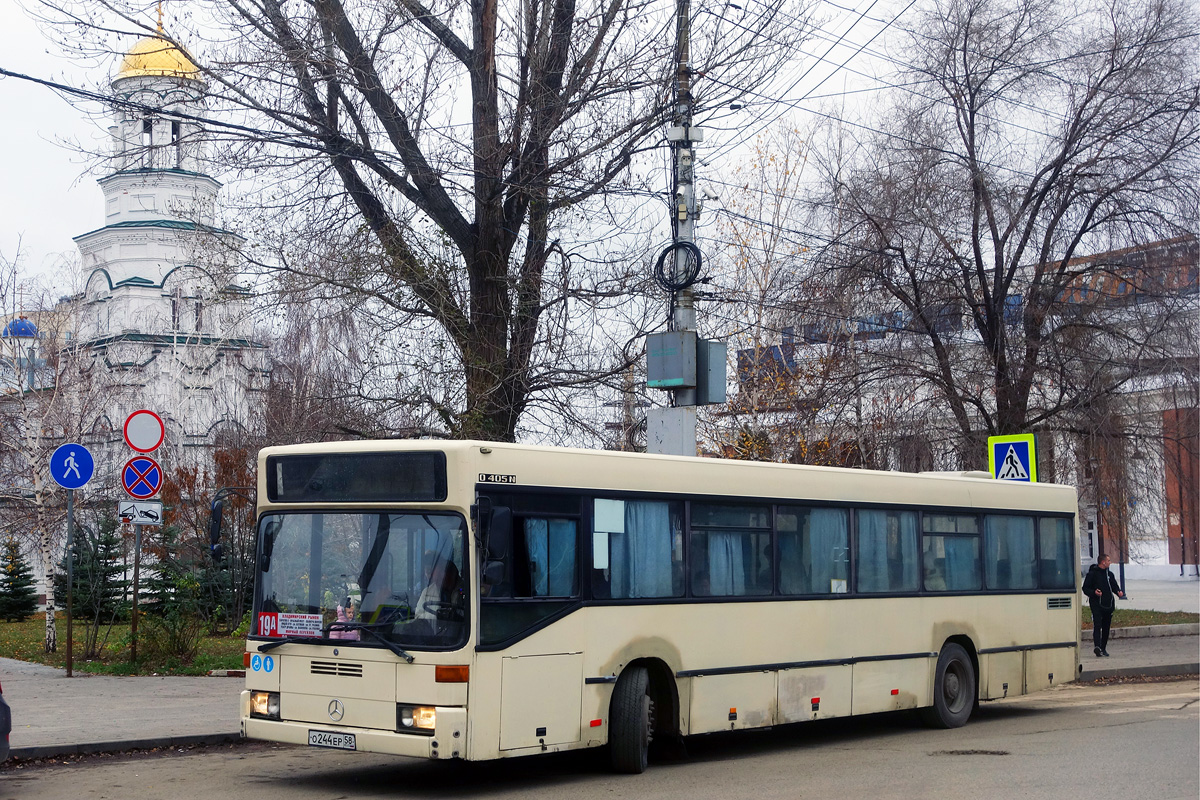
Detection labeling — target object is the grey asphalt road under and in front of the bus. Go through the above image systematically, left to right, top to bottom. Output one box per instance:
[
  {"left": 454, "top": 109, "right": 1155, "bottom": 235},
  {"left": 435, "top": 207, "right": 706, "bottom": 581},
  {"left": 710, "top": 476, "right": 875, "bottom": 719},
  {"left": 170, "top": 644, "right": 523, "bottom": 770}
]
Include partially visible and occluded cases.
[{"left": 0, "top": 679, "right": 1200, "bottom": 800}]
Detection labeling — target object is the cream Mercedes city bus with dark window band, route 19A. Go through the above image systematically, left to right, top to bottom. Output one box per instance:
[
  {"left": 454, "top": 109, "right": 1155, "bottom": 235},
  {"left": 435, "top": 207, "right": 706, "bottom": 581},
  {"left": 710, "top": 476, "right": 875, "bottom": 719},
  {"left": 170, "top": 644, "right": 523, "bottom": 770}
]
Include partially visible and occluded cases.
[{"left": 225, "top": 440, "right": 1080, "bottom": 772}]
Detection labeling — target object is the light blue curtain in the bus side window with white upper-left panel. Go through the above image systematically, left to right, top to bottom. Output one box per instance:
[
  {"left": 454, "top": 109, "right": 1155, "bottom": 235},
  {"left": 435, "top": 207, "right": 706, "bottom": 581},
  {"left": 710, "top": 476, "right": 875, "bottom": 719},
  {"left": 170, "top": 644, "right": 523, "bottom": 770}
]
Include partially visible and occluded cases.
[{"left": 610, "top": 500, "right": 672, "bottom": 597}]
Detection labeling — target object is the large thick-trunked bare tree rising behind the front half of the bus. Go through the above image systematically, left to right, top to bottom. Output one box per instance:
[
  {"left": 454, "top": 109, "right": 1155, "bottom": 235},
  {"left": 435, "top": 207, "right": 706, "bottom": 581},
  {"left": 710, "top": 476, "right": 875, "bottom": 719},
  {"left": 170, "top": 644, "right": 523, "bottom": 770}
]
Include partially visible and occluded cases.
[{"left": 46, "top": 0, "right": 806, "bottom": 439}]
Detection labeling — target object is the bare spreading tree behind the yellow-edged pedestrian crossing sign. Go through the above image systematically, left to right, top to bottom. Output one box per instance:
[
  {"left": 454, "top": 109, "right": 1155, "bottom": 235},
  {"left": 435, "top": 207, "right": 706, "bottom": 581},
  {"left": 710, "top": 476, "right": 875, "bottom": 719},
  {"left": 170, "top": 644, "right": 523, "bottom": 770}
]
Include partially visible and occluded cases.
[{"left": 806, "top": 0, "right": 1200, "bottom": 453}]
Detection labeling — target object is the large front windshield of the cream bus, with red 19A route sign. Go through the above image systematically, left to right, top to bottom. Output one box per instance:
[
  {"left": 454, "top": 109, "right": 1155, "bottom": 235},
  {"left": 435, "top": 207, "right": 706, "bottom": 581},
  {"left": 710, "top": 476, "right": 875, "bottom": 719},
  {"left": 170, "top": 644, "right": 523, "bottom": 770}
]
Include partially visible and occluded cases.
[{"left": 253, "top": 511, "right": 468, "bottom": 650}]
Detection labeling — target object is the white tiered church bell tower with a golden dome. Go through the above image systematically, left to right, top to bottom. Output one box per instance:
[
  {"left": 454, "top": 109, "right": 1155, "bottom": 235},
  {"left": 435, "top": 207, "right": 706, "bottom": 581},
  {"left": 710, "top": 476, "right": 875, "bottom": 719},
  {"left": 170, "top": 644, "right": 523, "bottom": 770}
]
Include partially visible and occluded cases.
[{"left": 74, "top": 37, "right": 266, "bottom": 465}]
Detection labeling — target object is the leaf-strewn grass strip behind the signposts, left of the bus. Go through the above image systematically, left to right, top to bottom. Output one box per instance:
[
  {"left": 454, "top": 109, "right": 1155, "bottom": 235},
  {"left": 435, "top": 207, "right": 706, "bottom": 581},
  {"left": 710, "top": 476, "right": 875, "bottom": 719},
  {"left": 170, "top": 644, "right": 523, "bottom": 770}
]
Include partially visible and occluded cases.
[{"left": 0, "top": 613, "right": 246, "bottom": 675}]
